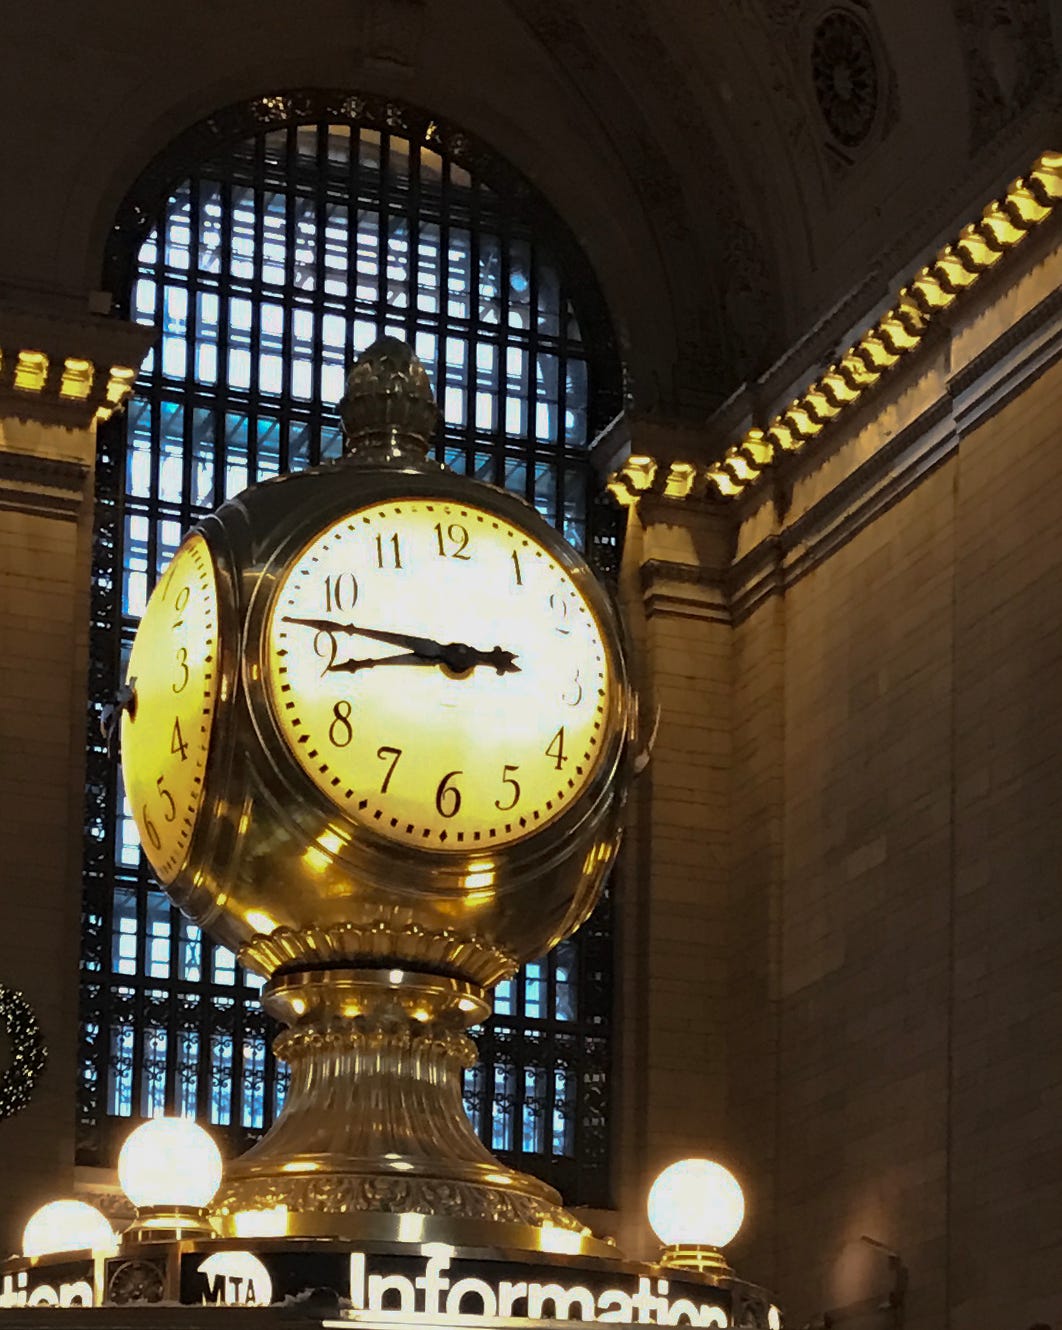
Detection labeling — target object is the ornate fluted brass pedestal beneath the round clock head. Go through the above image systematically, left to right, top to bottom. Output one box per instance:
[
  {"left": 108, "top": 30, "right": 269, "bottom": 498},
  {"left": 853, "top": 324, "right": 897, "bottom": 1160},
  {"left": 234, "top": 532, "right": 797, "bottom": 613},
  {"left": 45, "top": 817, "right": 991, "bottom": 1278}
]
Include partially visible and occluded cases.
[{"left": 213, "top": 970, "right": 615, "bottom": 1257}]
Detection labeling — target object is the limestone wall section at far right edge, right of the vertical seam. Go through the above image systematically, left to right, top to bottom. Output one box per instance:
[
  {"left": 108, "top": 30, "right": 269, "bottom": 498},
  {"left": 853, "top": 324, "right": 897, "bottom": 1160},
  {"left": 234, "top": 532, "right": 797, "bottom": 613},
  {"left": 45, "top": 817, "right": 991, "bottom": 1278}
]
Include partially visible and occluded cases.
[{"left": 949, "top": 351, "right": 1062, "bottom": 1330}]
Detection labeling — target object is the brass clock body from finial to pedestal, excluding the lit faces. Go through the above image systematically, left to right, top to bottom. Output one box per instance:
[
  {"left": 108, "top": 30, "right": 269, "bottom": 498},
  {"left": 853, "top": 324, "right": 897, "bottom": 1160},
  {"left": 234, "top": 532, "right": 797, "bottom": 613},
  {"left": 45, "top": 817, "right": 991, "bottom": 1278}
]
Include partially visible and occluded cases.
[{"left": 124, "top": 338, "right": 635, "bottom": 1254}]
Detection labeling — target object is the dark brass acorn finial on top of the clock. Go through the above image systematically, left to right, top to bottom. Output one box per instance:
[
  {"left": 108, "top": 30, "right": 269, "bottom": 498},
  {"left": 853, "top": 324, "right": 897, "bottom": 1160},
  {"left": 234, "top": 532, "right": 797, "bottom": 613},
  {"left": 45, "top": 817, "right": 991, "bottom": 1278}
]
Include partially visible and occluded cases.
[{"left": 339, "top": 336, "right": 437, "bottom": 462}]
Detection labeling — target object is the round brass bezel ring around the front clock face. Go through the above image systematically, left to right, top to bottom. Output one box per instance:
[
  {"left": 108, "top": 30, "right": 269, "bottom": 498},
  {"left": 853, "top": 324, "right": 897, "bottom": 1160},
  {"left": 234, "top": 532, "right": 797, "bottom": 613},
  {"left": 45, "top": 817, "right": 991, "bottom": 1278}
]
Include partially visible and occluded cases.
[{"left": 242, "top": 464, "right": 631, "bottom": 895}]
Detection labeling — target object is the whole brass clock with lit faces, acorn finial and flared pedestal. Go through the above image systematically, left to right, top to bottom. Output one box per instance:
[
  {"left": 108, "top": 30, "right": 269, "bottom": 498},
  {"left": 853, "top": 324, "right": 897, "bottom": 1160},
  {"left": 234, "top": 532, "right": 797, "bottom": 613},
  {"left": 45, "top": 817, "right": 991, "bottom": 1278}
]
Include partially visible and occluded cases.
[{"left": 122, "top": 338, "right": 635, "bottom": 1253}]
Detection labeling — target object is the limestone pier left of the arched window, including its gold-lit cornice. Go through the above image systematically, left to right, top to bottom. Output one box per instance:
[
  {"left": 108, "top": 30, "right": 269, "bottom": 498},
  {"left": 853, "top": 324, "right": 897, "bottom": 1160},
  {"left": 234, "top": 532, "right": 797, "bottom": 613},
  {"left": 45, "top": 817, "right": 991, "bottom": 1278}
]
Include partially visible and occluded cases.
[{"left": 0, "top": 299, "right": 154, "bottom": 1256}]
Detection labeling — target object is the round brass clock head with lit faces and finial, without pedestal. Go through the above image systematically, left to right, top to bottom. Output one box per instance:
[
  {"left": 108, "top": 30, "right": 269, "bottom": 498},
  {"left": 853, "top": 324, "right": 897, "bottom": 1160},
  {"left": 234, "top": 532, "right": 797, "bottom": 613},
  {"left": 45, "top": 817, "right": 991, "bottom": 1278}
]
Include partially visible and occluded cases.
[{"left": 122, "top": 339, "right": 633, "bottom": 986}]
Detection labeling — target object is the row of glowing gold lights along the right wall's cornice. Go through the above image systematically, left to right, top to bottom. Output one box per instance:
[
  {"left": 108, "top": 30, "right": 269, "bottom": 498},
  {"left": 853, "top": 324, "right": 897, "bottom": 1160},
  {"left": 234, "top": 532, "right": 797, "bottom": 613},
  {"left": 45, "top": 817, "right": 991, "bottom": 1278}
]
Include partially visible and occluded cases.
[{"left": 608, "top": 152, "right": 1062, "bottom": 507}]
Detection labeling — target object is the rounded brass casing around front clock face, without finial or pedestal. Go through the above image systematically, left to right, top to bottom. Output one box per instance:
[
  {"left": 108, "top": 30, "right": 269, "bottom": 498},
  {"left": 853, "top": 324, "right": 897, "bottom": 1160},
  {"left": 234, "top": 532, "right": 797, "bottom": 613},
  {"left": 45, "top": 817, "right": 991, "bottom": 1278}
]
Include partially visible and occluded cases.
[{"left": 169, "top": 464, "right": 632, "bottom": 987}]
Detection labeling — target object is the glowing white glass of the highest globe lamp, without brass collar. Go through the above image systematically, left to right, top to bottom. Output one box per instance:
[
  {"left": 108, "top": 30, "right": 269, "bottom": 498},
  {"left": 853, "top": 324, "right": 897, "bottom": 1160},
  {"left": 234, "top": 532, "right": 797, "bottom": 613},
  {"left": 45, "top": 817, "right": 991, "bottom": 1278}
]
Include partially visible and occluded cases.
[{"left": 118, "top": 1117, "right": 221, "bottom": 1210}]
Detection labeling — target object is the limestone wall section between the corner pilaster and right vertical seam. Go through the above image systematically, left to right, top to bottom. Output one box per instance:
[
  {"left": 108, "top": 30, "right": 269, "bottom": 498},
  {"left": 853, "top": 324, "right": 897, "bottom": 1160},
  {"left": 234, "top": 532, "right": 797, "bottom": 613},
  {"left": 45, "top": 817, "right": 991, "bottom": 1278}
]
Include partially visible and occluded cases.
[{"left": 775, "top": 467, "right": 953, "bottom": 1325}]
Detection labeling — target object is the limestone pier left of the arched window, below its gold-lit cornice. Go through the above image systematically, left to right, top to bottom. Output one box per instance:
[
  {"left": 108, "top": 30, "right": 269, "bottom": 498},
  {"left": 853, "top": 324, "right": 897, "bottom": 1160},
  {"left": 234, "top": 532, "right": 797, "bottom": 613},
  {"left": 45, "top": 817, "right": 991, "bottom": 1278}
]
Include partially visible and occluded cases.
[{"left": 0, "top": 419, "right": 94, "bottom": 1254}]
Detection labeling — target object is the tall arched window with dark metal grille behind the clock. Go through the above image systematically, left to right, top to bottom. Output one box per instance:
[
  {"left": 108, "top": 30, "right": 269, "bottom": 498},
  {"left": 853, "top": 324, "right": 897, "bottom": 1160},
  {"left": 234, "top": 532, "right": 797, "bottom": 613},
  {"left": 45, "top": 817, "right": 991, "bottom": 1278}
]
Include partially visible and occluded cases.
[{"left": 79, "top": 94, "right": 620, "bottom": 1204}]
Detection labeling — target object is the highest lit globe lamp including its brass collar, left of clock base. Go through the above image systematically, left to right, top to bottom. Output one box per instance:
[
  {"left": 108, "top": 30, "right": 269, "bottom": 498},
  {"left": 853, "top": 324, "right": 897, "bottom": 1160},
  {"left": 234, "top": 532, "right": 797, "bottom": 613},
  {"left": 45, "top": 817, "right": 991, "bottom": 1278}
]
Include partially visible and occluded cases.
[{"left": 118, "top": 1117, "right": 221, "bottom": 1242}]
